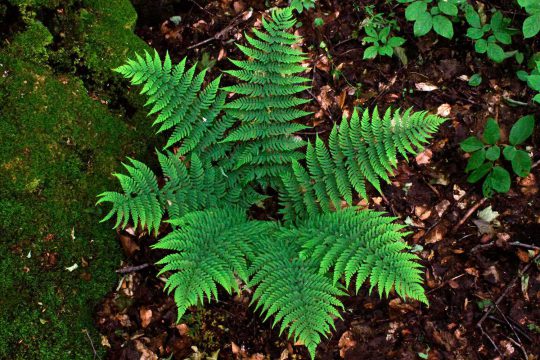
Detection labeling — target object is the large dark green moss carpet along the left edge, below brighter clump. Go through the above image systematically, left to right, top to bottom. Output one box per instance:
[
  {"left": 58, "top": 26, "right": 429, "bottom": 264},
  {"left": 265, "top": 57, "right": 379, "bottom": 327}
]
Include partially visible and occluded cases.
[{"left": 0, "top": 22, "right": 148, "bottom": 360}]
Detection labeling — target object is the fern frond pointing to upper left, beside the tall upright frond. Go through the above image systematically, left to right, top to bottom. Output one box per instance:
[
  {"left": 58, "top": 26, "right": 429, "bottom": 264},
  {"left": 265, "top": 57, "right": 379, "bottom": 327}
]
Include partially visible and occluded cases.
[{"left": 115, "top": 52, "right": 226, "bottom": 155}]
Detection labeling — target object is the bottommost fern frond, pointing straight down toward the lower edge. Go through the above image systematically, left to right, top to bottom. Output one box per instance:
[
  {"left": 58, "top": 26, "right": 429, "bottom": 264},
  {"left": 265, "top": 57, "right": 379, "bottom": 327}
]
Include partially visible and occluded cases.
[{"left": 249, "top": 233, "right": 345, "bottom": 358}]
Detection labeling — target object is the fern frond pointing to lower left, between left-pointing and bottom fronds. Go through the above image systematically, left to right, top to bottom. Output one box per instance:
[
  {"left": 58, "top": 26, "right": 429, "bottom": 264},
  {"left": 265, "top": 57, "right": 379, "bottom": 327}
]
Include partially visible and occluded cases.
[{"left": 152, "top": 207, "right": 275, "bottom": 321}]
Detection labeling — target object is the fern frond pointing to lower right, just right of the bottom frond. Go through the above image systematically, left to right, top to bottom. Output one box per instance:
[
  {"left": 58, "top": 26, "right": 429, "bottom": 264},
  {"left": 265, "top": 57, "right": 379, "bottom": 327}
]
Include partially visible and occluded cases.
[{"left": 288, "top": 208, "right": 428, "bottom": 304}]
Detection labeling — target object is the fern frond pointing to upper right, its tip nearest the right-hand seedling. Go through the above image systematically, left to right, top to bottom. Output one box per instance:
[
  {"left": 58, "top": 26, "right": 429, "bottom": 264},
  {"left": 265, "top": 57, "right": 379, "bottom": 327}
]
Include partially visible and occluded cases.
[{"left": 281, "top": 108, "right": 445, "bottom": 220}]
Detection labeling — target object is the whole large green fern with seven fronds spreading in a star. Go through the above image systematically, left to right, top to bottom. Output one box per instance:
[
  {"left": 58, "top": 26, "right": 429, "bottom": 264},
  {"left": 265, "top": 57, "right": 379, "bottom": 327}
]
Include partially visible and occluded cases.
[{"left": 98, "top": 8, "right": 444, "bottom": 356}]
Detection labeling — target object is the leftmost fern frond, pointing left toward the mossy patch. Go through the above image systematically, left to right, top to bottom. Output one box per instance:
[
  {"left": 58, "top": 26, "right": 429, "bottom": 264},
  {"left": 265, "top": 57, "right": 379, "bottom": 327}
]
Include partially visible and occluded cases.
[{"left": 97, "top": 152, "right": 264, "bottom": 234}]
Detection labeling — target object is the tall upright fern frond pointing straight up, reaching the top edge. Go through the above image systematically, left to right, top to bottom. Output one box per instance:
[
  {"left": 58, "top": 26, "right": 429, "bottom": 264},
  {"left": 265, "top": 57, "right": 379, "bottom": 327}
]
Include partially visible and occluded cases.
[{"left": 223, "top": 8, "right": 310, "bottom": 183}]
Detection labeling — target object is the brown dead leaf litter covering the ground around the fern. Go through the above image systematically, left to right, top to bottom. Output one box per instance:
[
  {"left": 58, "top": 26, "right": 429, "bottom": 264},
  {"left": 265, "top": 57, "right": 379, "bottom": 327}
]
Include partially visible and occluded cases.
[{"left": 95, "top": 0, "right": 540, "bottom": 359}]
